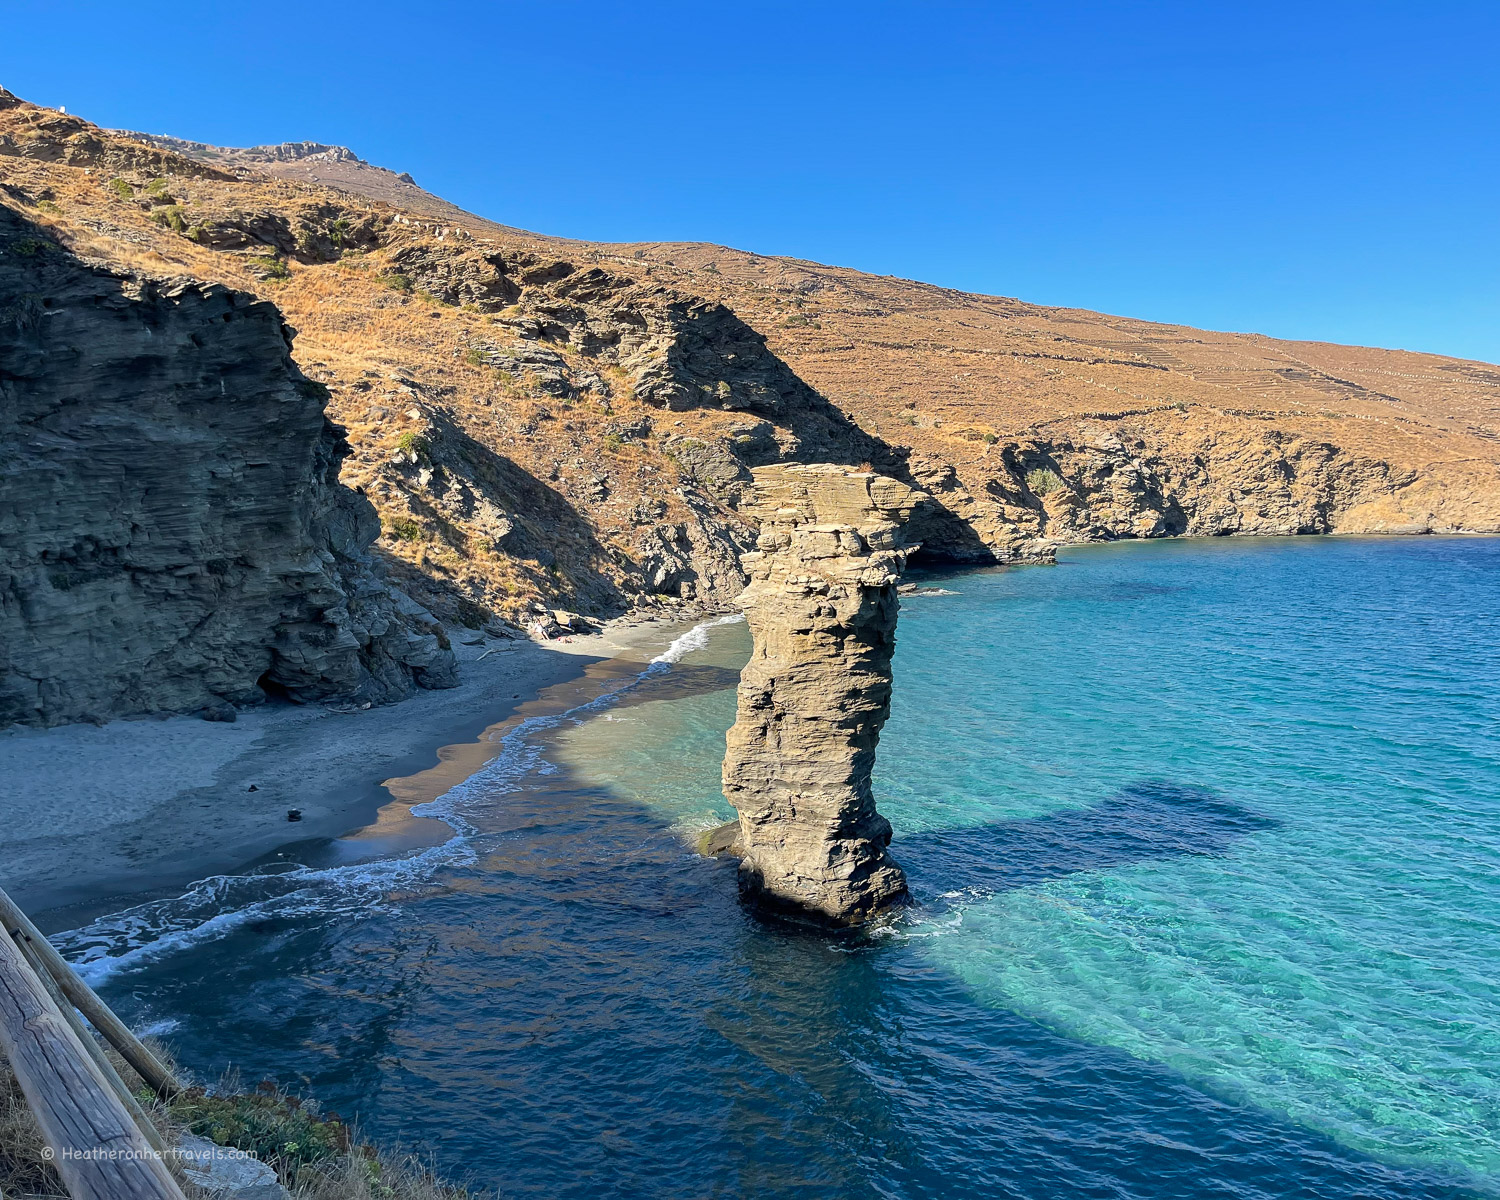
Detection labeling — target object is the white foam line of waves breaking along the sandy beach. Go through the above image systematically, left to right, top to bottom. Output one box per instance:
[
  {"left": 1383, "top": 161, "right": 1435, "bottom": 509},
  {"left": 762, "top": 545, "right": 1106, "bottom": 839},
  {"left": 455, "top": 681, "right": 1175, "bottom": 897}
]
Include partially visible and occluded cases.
[{"left": 54, "top": 615, "right": 744, "bottom": 984}]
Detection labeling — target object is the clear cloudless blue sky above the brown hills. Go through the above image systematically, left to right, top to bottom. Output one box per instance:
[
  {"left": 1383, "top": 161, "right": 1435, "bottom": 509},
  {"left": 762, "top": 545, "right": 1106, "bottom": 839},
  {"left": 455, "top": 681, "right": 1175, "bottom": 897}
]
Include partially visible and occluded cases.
[{"left": 0, "top": 0, "right": 1500, "bottom": 362}]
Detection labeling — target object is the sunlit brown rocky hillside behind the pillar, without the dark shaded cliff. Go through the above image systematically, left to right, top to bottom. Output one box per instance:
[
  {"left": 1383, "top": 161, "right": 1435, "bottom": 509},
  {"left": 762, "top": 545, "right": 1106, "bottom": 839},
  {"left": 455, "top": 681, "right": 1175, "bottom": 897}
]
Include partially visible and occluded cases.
[{"left": 0, "top": 87, "right": 1500, "bottom": 633}]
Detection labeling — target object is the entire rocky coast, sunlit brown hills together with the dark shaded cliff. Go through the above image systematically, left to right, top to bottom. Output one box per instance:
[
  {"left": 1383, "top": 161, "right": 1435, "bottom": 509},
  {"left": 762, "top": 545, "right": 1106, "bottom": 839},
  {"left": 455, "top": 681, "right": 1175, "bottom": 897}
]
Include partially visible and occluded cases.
[{"left": 0, "top": 82, "right": 1500, "bottom": 732}]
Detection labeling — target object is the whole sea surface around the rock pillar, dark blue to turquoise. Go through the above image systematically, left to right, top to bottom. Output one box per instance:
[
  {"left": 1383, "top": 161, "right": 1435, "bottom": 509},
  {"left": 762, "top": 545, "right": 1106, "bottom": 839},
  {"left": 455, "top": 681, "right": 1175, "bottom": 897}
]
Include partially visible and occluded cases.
[{"left": 58, "top": 539, "right": 1500, "bottom": 1200}]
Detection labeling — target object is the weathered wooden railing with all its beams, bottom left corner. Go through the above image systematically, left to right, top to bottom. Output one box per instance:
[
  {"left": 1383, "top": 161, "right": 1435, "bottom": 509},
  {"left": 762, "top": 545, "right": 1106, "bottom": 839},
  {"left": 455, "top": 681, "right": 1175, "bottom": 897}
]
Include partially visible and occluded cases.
[{"left": 0, "top": 891, "right": 183, "bottom": 1200}]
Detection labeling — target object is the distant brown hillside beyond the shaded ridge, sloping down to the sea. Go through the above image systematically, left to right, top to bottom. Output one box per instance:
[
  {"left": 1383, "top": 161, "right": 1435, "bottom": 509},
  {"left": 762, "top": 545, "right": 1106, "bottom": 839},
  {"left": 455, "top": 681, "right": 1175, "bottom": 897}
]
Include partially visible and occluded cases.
[{"left": 621, "top": 245, "right": 1500, "bottom": 558}]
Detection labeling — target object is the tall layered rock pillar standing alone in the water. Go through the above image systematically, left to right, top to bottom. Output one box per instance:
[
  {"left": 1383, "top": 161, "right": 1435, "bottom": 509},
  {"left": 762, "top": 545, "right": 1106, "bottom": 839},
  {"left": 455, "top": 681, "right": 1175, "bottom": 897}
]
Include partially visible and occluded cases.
[{"left": 723, "top": 465, "right": 923, "bottom": 926}]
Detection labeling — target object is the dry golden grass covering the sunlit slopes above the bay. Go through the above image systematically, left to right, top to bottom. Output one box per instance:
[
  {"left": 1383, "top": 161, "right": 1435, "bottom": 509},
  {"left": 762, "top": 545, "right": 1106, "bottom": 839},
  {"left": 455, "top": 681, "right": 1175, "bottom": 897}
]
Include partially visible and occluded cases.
[{"left": 0, "top": 85, "right": 1500, "bottom": 609}]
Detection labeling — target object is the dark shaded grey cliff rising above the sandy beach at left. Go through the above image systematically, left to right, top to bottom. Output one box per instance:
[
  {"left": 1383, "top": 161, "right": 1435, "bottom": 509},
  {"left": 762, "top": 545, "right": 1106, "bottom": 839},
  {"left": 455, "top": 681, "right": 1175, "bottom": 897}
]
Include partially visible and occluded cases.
[{"left": 0, "top": 209, "right": 455, "bottom": 726}]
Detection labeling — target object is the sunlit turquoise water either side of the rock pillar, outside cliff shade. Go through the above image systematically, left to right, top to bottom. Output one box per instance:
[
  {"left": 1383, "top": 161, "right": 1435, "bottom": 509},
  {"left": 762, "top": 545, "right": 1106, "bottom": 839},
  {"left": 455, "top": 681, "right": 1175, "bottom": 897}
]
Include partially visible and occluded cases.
[{"left": 558, "top": 539, "right": 1500, "bottom": 1176}]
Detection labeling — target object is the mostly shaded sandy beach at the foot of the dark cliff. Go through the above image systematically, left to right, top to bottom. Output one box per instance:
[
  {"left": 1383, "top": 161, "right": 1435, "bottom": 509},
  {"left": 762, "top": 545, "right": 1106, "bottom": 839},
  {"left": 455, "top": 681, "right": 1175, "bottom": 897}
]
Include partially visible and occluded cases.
[{"left": 0, "top": 618, "right": 702, "bottom": 933}]
